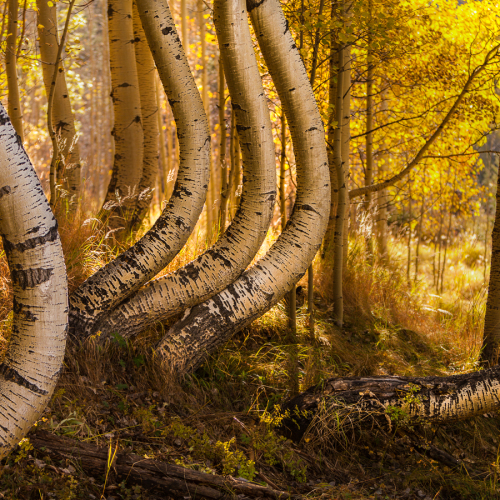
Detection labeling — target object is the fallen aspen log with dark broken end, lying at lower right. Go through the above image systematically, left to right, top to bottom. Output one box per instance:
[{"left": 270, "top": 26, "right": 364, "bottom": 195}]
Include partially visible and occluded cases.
[{"left": 281, "top": 366, "right": 500, "bottom": 441}]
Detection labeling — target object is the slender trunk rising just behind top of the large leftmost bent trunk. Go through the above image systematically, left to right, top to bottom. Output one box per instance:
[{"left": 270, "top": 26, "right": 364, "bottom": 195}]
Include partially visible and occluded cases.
[{"left": 5, "top": 0, "right": 24, "bottom": 141}]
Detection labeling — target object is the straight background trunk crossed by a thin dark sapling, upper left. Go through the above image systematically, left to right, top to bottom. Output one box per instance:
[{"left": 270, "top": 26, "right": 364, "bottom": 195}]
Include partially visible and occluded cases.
[{"left": 36, "top": 0, "right": 81, "bottom": 205}]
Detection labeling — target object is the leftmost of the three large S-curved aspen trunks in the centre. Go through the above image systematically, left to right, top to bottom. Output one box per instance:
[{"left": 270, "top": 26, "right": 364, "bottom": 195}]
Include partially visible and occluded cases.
[{"left": 70, "top": 0, "right": 210, "bottom": 337}]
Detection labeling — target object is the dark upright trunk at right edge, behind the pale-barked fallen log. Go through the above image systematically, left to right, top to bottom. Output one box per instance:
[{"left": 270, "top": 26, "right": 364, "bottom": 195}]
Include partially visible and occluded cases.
[{"left": 482, "top": 167, "right": 500, "bottom": 366}]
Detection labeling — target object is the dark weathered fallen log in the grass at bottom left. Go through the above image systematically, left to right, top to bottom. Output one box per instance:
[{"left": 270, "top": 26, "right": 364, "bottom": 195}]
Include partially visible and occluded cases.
[{"left": 29, "top": 431, "right": 302, "bottom": 500}]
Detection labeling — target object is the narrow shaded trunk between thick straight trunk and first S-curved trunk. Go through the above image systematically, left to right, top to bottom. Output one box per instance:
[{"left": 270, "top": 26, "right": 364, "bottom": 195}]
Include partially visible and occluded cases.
[{"left": 129, "top": 3, "right": 159, "bottom": 230}]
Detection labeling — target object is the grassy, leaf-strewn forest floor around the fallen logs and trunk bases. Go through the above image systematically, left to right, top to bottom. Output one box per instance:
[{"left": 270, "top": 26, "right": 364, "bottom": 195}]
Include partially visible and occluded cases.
[{"left": 0, "top": 222, "right": 500, "bottom": 500}]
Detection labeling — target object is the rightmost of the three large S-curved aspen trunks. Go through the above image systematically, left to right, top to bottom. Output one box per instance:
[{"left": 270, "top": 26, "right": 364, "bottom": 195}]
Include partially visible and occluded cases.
[{"left": 155, "top": 0, "right": 330, "bottom": 375}]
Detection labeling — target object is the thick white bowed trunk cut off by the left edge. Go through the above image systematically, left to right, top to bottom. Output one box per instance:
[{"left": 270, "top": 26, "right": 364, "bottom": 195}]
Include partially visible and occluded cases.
[{"left": 0, "top": 104, "right": 68, "bottom": 457}]
